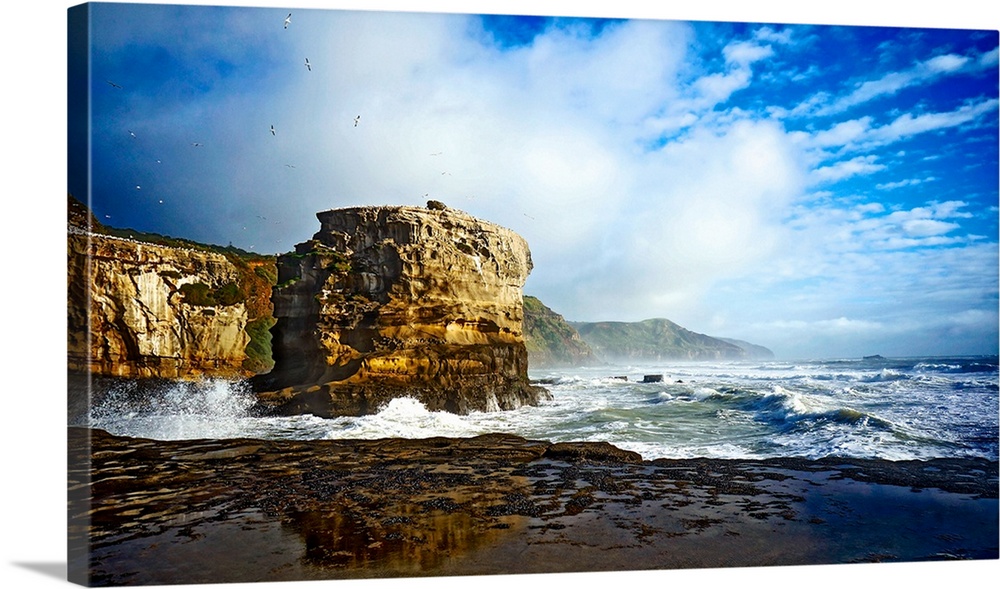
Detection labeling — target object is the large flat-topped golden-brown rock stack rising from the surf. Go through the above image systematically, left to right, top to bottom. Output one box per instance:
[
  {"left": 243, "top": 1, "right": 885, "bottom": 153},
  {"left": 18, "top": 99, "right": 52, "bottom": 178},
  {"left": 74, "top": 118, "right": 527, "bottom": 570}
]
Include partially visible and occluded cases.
[{"left": 255, "top": 202, "right": 548, "bottom": 416}]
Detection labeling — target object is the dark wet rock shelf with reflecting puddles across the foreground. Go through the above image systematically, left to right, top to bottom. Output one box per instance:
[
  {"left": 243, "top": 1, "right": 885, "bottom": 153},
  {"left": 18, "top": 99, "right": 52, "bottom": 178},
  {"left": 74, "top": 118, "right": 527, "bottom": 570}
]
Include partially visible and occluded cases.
[{"left": 69, "top": 428, "right": 1000, "bottom": 585}]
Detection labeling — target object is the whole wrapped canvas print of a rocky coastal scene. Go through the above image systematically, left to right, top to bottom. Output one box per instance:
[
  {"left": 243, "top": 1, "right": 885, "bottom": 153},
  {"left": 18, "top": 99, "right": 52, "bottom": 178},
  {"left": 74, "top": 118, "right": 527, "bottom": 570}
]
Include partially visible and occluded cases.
[{"left": 67, "top": 2, "right": 1000, "bottom": 586}]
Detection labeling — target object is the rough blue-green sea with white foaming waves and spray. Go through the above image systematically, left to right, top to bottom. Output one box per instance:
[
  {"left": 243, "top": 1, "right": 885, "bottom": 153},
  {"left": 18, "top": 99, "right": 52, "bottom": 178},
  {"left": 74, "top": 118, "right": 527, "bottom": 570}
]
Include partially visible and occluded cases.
[{"left": 86, "top": 356, "right": 1000, "bottom": 461}]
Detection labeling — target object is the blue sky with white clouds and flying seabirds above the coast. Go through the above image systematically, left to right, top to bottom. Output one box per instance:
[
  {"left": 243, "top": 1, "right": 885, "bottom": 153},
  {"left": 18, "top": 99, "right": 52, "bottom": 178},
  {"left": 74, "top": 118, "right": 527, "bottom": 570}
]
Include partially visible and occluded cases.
[{"left": 68, "top": 3, "right": 1000, "bottom": 358}]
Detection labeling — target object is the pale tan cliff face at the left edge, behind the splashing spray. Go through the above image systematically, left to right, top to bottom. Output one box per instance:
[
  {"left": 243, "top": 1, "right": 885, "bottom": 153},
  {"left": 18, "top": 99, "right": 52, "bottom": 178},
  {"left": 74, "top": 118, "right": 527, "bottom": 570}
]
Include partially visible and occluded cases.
[{"left": 67, "top": 225, "right": 249, "bottom": 378}]
